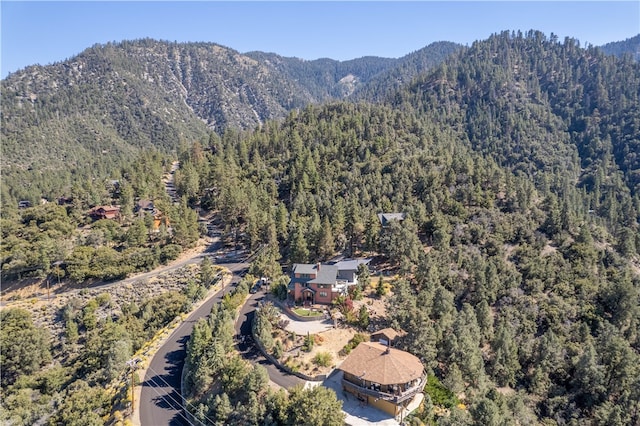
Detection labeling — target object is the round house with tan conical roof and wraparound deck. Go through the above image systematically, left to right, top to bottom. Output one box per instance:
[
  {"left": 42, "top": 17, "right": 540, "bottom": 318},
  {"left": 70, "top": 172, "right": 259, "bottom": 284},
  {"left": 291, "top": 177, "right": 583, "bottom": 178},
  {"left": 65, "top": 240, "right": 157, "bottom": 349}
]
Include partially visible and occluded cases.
[{"left": 338, "top": 342, "right": 427, "bottom": 416}]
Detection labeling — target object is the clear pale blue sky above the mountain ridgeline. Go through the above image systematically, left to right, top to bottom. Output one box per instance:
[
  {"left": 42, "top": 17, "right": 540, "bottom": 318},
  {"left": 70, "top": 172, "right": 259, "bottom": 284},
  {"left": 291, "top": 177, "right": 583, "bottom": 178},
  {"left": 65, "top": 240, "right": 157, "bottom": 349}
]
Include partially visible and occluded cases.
[{"left": 0, "top": 0, "right": 640, "bottom": 78}]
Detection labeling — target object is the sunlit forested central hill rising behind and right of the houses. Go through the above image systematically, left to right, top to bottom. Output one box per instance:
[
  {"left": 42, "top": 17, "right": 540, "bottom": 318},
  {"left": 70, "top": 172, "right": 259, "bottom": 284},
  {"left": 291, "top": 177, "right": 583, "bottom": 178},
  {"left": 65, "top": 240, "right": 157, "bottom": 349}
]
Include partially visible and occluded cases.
[{"left": 175, "top": 98, "right": 640, "bottom": 425}]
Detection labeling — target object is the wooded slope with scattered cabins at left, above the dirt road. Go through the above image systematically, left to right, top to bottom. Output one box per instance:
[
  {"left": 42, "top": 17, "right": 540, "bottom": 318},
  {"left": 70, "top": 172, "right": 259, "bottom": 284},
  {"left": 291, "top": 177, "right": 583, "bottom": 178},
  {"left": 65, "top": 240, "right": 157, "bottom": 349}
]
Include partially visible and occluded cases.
[{"left": 0, "top": 151, "right": 200, "bottom": 282}]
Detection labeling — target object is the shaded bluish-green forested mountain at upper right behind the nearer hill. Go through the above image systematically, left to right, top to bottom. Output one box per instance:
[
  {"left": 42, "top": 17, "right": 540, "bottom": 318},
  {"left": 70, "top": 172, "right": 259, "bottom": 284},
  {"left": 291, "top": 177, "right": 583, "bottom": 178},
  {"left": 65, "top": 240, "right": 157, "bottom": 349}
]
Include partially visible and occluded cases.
[{"left": 396, "top": 31, "right": 640, "bottom": 198}]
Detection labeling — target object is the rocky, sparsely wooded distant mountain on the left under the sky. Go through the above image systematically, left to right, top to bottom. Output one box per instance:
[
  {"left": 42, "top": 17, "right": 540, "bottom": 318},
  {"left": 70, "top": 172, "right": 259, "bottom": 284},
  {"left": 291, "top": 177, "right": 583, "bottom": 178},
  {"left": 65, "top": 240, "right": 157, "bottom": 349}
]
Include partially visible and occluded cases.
[{"left": 1, "top": 39, "right": 460, "bottom": 175}]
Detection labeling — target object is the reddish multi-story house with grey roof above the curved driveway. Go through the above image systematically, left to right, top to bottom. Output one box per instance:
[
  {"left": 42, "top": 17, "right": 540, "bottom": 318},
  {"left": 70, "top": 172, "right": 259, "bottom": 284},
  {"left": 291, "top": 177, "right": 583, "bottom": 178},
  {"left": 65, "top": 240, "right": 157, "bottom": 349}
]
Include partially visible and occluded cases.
[{"left": 289, "top": 259, "right": 371, "bottom": 305}]
